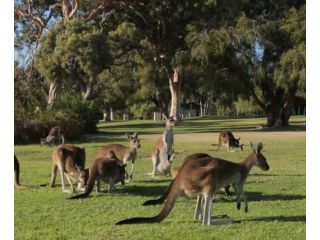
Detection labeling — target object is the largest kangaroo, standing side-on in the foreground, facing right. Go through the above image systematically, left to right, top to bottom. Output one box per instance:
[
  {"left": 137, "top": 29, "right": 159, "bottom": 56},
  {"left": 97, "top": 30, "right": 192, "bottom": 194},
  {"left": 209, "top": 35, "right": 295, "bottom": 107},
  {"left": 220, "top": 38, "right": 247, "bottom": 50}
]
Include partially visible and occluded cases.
[{"left": 116, "top": 143, "right": 269, "bottom": 225}]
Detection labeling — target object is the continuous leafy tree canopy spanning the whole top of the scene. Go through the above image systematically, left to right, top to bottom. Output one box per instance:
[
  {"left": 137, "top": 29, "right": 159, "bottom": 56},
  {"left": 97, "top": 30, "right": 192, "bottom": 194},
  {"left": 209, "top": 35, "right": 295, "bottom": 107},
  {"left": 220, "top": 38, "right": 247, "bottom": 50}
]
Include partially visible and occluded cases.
[{"left": 15, "top": 0, "right": 306, "bottom": 126}]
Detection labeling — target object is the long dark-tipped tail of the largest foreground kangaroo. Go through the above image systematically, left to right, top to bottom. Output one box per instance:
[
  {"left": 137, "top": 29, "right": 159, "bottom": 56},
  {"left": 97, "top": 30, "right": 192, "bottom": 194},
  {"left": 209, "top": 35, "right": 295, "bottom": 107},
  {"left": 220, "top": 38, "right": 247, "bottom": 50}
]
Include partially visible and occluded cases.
[{"left": 116, "top": 180, "right": 180, "bottom": 225}]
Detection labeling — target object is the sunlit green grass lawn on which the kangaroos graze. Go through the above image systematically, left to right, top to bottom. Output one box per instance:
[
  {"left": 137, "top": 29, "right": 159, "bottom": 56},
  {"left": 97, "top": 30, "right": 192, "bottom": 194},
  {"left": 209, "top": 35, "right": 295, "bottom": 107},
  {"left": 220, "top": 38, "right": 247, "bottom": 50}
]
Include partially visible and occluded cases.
[{"left": 14, "top": 117, "right": 306, "bottom": 240}]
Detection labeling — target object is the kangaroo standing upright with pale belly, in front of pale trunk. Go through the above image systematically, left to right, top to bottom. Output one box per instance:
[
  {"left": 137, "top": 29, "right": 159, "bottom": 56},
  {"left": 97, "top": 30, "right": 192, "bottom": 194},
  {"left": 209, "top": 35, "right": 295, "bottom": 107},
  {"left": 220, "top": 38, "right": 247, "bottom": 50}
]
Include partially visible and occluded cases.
[{"left": 151, "top": 117, "right": 176, "bottom": 177}]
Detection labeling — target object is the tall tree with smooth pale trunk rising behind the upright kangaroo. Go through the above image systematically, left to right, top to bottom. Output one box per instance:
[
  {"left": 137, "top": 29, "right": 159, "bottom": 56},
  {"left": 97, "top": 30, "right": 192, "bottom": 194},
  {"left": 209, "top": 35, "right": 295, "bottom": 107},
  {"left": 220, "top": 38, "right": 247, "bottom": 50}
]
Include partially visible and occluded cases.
[{"left": 96, "top": 0, "right": 218, "bottom": 119}]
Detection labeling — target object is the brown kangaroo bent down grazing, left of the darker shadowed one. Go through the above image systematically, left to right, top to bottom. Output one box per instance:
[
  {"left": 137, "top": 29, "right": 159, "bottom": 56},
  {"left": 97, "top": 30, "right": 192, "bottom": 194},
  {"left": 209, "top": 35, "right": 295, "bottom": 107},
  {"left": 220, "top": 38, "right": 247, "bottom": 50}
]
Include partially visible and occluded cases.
[{"left": 49, "top": 144, "right": 89, "bottom": 193}]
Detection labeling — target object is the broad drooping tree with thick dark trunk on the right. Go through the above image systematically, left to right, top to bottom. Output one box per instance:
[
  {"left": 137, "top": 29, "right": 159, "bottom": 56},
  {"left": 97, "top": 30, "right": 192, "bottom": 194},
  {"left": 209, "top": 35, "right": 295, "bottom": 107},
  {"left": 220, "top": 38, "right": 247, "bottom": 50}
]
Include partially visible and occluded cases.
[{"left": 187, "top": 1, "right": 305, "bottom": 127}]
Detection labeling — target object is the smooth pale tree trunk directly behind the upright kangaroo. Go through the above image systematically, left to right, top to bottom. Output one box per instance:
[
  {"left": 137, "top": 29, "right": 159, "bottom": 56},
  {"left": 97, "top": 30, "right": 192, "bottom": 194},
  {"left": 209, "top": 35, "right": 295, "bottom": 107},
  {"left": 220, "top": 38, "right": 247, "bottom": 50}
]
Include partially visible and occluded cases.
[{"left": 169, "top": 68, "right": 182, "bottom": 121}]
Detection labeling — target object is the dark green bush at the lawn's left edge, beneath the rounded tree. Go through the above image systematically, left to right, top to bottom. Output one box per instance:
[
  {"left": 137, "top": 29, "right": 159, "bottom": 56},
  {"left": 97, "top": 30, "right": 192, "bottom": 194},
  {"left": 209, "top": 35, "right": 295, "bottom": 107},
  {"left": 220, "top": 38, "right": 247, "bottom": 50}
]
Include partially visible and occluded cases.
[{"left": 14, "top": 97, "right": 101, "bottom": 143}]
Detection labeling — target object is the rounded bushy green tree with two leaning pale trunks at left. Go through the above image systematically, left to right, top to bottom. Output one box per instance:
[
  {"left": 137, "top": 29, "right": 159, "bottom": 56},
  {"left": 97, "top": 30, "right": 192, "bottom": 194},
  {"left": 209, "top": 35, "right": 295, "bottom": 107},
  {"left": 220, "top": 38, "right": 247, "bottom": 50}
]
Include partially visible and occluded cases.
[{"left": 36, "top": 18, "right": 112, "bottom": 109}]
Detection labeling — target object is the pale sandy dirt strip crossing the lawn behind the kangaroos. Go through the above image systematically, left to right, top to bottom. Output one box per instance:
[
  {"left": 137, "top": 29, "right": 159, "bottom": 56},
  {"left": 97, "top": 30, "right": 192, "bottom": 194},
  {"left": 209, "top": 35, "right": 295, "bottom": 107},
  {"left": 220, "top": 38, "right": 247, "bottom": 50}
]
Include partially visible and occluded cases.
[{"left": 140, "top": 131, "right": 306, "bottom": 143}]
